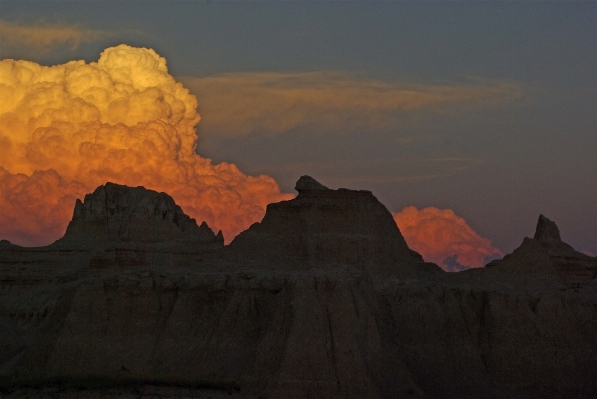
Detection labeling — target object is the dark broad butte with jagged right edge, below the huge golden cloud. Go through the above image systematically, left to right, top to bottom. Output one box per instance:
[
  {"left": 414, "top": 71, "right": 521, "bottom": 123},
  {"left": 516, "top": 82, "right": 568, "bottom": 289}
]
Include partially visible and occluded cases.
[{"left": 61, "top": 183, "right": 224, "bottom": 268}]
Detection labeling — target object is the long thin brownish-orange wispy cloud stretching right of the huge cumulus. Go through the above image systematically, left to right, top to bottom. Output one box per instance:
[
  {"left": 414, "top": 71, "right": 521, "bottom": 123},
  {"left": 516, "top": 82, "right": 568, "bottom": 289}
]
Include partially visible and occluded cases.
[{"left": 181, "top": 71, "right": 525, "bottom": 137}]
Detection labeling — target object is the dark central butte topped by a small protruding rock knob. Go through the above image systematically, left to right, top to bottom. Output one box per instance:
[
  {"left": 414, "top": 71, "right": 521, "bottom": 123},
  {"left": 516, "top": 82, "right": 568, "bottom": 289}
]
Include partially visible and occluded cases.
[{"left": 228, "top": 176, "right": 418, "bottom": 278}]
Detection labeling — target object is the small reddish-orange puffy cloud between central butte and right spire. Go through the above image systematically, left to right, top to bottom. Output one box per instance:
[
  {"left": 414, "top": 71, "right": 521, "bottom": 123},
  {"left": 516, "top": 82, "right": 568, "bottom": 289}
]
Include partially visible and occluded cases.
[{"left": 393, "top": 206, "right": 503, "bottom": 271}]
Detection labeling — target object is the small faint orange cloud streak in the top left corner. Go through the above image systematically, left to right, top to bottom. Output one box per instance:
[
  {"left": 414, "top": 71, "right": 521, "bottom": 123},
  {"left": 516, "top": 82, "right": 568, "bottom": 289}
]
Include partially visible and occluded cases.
[{"left": 0, "top": 20, "right": 112, "bottom": 53}]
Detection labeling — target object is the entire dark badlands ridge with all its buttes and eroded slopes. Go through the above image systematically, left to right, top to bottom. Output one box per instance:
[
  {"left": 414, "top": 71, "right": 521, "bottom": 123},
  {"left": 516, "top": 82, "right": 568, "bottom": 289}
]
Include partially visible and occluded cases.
[{"left": 0, "top": 176, "right": 597, "bottom": 399}]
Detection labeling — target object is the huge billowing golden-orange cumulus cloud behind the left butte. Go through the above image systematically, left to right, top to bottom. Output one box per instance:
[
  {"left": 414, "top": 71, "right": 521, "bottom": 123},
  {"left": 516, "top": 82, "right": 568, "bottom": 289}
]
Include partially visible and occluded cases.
[{"left": 0, "top": 45, "right": 292, "bottom": 245}]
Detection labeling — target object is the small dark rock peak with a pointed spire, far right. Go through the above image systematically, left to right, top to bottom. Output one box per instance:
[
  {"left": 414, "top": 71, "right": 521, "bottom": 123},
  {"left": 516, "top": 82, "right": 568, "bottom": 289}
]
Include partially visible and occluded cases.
[{"left": 487, "top": 215, "right": 597, "bottom": 288}]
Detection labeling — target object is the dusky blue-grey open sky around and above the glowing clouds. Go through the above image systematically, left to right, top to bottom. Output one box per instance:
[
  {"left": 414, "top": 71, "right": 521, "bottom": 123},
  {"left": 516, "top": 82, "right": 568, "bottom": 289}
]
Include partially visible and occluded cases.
[{"left": 0, "top": 1, "right": 597, "bottom": 254}]
